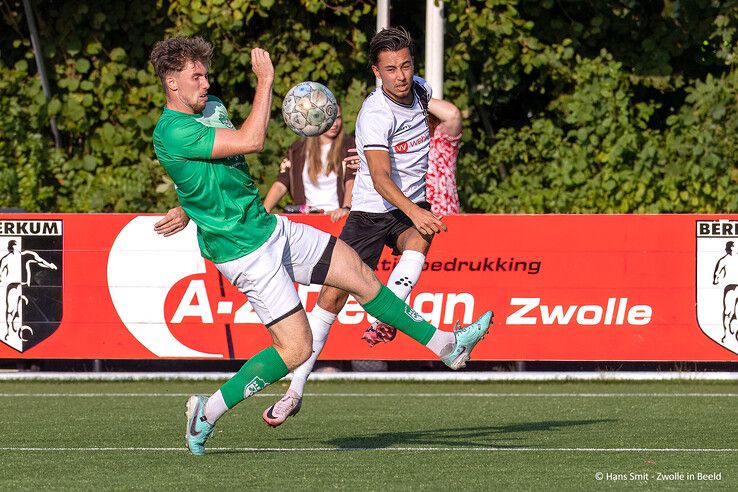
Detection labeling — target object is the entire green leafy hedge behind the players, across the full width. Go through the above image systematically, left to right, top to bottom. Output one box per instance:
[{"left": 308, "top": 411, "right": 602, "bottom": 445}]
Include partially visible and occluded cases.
[{"left": 0, "top": 0, "right": 738, "bottom": 213}]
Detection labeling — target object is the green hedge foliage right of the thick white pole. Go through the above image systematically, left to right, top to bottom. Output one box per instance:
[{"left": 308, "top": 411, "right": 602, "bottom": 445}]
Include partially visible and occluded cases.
[{"left": 436, "top": 0, "right": 738, "bottom": 213}]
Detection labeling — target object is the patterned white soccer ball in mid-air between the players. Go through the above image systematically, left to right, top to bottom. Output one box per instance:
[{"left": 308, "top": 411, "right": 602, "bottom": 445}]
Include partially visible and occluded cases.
[{"left": 282, "top": 81, "right": 338, "bottom": 137}]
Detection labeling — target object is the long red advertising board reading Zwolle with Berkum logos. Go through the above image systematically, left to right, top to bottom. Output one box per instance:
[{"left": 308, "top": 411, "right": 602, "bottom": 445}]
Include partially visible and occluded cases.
[{"left": 0, "top": 214, "right": 738, "bottom": 361}]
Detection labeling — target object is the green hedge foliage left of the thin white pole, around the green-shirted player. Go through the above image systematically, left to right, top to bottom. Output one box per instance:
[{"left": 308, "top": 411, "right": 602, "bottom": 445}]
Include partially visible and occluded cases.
[{"left": 0, "top": 0, "right": 374, "bottom": 212}]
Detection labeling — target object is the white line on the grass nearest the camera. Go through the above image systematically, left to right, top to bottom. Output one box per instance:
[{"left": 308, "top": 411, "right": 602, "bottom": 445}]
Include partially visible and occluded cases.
[{"left": 0, "top": 447, "right": 738, "bottom": 453}]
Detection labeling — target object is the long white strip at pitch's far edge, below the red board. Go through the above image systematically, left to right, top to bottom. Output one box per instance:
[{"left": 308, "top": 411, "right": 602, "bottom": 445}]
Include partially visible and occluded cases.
[{"left": 0, "top": 371, "right": 738, "bottom": 382}]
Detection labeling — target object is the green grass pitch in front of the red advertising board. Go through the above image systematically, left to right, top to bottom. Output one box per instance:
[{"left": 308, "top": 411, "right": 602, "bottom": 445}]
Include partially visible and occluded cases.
[{"left": 0, "top": 381, "right": 738, "bottom": 492}]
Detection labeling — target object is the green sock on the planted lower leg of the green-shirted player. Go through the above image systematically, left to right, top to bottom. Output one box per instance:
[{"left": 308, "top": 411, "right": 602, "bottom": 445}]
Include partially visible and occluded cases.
[{"left": 220, "top": 346, "right": 289, "bottom": 408}]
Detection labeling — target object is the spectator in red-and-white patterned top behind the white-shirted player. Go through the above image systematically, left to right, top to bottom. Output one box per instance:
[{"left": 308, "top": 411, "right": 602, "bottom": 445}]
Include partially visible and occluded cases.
[{"left": 425, "top": 99, "right": 461, "bottom": 216}]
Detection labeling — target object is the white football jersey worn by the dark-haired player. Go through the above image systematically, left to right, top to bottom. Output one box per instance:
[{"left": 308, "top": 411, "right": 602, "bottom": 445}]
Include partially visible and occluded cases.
[{"left": 351, "top": 76, "right": 431, "bottom": 213}]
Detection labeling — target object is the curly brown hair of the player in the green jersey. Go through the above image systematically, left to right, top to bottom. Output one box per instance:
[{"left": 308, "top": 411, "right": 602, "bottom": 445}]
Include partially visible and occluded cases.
[{"left": 150, "top": 36, "right": 213, "bottom": 87}]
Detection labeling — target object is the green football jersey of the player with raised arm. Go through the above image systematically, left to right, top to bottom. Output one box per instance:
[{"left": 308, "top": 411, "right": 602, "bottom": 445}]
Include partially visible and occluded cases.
[{"left": 154, "top": 96, "right": 277, "bottom": 263}]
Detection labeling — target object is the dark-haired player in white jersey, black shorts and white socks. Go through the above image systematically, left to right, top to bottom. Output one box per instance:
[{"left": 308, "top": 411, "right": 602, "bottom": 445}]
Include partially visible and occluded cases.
[{"left": 262, "top": 28, "right": 491, "bottom": 427}]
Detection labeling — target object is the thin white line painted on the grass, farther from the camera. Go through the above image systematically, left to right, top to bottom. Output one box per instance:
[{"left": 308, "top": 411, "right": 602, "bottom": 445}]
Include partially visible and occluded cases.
[{"left": 0, "top": 393, "right": 738, "bottom": 398}]
